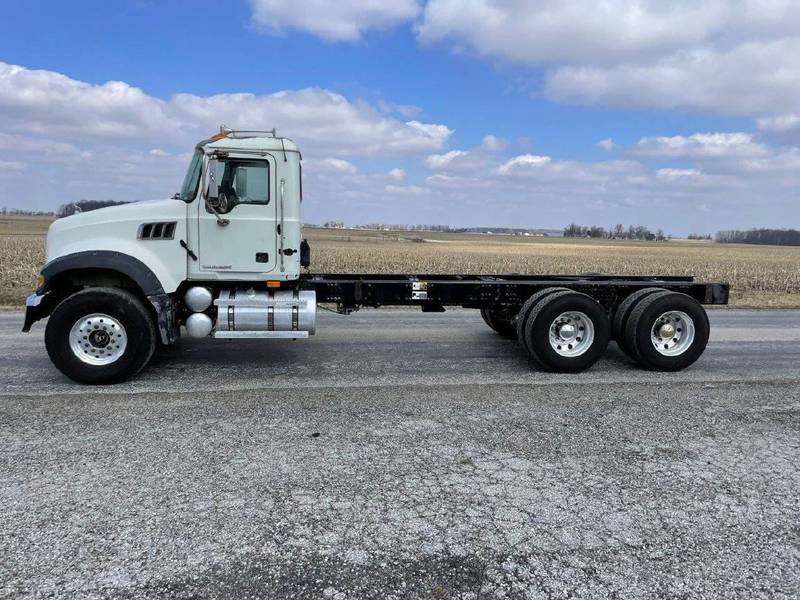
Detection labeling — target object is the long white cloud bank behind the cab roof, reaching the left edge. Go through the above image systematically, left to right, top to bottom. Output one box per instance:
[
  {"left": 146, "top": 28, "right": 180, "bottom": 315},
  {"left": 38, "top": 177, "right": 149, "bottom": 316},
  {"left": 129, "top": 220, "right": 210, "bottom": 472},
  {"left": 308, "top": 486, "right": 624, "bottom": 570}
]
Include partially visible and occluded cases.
[{"left": 0, "top": 63, "right": 453, "bottom": 156}]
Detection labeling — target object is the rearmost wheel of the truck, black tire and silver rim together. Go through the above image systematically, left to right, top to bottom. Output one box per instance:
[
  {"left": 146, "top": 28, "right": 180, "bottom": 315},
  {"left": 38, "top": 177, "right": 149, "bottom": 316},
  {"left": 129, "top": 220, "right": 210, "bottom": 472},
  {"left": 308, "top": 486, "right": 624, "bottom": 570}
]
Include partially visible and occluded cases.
[{"left": 625, "top": 291, "right": 710, "bottom": 371}]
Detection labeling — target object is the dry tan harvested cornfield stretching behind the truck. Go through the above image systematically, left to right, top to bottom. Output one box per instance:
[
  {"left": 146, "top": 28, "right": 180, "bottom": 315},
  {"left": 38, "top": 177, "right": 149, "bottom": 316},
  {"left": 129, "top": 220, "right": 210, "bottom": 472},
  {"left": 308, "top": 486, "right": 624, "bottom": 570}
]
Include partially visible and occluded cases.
[{"left": 0, "top": 217, "right": 800, "bottom": 307}]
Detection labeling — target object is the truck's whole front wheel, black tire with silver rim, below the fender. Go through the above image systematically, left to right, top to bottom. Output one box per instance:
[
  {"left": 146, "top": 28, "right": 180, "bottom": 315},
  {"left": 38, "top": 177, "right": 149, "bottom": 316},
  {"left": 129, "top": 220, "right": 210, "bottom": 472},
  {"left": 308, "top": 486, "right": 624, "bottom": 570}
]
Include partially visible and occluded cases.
[{"left": 44, "top": 288, "right": 156, "bottom": 384}]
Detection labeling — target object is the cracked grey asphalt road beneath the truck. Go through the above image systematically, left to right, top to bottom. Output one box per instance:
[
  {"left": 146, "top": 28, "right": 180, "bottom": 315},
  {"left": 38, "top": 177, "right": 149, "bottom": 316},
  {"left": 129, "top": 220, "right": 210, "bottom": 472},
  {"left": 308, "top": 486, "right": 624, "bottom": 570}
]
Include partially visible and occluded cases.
[{"left": 0, "top": 311, "right": 800, "bottom": 599}]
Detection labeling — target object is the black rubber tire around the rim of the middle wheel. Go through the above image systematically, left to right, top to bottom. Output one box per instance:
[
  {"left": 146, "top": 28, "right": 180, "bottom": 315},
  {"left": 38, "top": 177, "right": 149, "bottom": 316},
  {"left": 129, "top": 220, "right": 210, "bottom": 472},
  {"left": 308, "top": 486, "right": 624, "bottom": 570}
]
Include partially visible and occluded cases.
[{"left": 525, "top": 290, "right": 611, "bottom": 373}]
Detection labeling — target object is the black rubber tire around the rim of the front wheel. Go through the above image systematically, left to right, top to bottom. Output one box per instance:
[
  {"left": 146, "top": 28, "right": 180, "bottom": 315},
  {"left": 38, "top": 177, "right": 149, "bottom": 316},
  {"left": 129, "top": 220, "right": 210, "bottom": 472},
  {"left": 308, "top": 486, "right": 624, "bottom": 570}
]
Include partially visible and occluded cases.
[{"left": 44, "top": 288, "right": 156, "bottom": 385}]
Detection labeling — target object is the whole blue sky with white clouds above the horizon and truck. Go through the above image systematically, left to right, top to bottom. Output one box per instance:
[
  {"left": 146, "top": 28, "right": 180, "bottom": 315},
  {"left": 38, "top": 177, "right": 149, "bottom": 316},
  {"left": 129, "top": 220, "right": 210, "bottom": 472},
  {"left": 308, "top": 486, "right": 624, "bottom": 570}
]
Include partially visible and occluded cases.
[{"left": 0, "top": 0, "right": 800, "bottom": 234}]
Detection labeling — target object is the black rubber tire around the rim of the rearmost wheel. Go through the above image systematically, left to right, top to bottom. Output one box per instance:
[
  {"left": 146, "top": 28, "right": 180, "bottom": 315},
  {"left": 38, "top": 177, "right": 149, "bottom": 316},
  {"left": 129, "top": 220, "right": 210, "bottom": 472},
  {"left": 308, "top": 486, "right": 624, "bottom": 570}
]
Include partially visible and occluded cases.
[{"left": 625, "top": 291, "right": 710, "bottom": 371}]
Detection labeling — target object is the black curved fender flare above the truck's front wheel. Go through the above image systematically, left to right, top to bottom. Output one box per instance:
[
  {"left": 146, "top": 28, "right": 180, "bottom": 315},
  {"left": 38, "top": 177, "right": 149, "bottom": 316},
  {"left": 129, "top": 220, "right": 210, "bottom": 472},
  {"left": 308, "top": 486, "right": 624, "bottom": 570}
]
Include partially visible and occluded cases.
[{"left": 37, "top": 250, "right": 164, "bottom": 296}]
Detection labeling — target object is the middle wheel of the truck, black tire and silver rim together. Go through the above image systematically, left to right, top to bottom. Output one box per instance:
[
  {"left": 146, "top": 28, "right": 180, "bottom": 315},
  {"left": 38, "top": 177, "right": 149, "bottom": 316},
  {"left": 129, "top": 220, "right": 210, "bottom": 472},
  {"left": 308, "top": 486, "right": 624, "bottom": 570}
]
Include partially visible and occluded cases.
[{"left": 525, "top": 290, "right": 610, "bottom": 373}]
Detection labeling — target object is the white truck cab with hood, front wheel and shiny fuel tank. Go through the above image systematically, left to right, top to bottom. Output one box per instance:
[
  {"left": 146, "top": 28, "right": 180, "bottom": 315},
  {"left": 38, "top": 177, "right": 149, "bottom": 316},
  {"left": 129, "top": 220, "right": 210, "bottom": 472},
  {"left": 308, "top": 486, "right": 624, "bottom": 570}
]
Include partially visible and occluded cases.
[{"left": 23, "top": 126, "right": 316, "bottom": 383}]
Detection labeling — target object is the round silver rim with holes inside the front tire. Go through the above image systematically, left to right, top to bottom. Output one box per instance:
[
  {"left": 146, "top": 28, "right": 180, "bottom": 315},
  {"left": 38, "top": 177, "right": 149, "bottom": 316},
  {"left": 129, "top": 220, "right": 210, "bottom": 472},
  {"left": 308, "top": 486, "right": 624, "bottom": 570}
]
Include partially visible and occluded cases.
[{"left": 69, "top": 313, "right": 128, "bottom": 367}]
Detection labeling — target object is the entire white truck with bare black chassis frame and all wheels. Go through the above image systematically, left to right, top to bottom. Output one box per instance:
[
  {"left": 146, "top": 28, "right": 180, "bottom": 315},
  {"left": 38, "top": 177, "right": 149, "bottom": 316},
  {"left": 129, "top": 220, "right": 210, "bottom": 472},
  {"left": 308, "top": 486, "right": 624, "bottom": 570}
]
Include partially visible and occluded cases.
[{"left": 23, "top": 127, "right": 728, "bottom": 384}]
